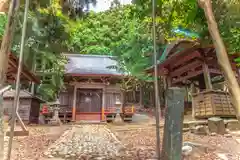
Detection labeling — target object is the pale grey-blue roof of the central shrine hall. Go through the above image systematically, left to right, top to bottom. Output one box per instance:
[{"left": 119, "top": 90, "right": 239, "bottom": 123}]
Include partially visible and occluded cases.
[{"left": 64, "top": 54, "right": 124, "bottom": 76}]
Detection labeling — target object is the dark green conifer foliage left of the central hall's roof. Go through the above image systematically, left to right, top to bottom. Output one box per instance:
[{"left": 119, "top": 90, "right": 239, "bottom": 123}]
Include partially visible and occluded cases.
[{"left": 9, "top": 1, "right": 70, "bottom": 100}]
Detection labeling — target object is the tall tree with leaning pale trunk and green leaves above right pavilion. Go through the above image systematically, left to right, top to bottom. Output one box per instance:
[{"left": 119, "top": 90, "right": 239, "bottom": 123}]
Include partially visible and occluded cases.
[{"left": 134, "top": 0, "right": 240, "bottom": 120}]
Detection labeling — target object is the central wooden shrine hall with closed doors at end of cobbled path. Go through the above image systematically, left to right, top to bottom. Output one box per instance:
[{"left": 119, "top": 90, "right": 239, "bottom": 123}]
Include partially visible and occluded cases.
[{"left": 59, "top": 54, "right": 128, "bottom": 121}]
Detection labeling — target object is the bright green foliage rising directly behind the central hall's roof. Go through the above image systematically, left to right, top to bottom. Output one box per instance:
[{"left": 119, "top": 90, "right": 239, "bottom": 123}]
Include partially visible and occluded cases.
[{"left": 68, "top": 5, "right": 152, "bottom": 88}]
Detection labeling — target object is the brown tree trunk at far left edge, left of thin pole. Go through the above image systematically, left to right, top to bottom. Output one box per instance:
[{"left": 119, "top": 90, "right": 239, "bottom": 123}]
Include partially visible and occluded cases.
[{"left": 0, "top": 0, "right": 19, "bottom": 159}]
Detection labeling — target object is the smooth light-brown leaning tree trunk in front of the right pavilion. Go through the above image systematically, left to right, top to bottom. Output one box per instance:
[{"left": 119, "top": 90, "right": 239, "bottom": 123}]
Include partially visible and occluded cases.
[{"left": 198, "top": 0, "right": 240, "bottom": 122}]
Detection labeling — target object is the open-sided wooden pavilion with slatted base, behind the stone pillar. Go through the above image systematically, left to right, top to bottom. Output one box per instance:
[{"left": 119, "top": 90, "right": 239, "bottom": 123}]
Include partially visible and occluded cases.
[{"left": 146, "top": 40, "right": 239, "bottom": 118}]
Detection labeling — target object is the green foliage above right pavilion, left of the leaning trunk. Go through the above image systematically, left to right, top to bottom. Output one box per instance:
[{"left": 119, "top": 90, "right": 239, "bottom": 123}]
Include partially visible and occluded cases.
[{"left": 134, "top": 0, "right": 206, "bottom": 44}]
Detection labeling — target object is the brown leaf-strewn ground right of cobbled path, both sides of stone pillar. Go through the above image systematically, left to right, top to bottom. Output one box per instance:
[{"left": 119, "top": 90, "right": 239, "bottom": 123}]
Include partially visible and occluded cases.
[{"left": 109, "top": 125, "right": 240, "bottom": 160}]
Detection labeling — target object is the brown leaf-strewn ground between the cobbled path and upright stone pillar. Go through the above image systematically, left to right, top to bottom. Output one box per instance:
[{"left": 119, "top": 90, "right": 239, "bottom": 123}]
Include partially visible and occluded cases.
[{"left": 109, "top": 125, "right": 162, "bottom": 160}]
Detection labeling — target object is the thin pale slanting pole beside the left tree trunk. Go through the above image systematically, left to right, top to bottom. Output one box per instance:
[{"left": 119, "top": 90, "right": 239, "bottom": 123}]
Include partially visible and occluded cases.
[{"left": 7, "top": 0, "right": 29, "bottom": 160}]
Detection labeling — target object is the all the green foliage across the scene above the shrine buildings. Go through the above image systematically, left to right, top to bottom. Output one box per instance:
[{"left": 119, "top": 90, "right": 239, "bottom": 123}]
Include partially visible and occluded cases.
[{"left": 3, "top": 0, "right": 240, "bottom": 99}]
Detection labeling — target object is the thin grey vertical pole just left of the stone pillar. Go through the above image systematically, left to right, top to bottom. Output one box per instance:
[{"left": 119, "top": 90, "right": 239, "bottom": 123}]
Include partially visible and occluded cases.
[{"left": 152, "top": 0, "right": 161, "bottom": 160}]
